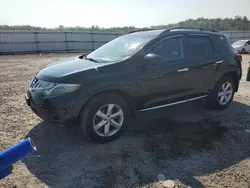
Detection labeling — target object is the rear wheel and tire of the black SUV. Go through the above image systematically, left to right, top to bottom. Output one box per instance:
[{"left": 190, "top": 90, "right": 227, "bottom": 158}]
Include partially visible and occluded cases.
[{"left": 207, "top": 76, "right": 236, "bottom": 109}]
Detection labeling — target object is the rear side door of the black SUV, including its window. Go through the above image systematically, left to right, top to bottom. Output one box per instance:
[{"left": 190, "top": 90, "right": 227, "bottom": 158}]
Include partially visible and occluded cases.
[{"left": 187, "top": 34, "right": 219, "bottom": 97}]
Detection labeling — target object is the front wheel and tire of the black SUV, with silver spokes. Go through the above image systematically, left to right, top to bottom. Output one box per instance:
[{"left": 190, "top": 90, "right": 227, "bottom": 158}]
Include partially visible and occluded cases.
[{"left": 80, "top": 94, "right": 129, "bottom": 142}]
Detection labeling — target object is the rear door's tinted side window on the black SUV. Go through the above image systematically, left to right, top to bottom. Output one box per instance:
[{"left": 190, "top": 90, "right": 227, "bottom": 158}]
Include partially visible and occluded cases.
[{"left": 188, "top": 36, "right": 214, "bottom": 58}]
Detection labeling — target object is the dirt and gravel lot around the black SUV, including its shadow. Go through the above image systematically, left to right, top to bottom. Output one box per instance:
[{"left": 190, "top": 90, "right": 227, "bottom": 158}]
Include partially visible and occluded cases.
[{"left": 0, "top": 54, "right": 250, "bottom": 188}]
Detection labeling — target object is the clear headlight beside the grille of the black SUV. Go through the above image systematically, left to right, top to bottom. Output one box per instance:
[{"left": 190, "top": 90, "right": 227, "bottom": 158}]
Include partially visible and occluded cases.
[{"left": 43, "top": 84, "right": 81, "bottom": 95}]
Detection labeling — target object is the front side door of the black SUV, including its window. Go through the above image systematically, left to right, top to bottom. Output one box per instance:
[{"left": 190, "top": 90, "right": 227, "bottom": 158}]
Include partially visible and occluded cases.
[{"left": 137, "top": 35, "right": 191, "bottom": 111}]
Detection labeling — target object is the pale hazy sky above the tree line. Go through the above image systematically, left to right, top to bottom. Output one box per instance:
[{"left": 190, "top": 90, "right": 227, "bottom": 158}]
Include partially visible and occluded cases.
[{"left": 0, "top": 0, "right": 250, "bottom": 28}]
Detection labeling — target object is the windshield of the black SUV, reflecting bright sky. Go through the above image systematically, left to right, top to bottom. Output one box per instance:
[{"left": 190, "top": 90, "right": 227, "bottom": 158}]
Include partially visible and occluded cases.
[{"left": 87, "top": 35, "right": 154, "bottom": 62}]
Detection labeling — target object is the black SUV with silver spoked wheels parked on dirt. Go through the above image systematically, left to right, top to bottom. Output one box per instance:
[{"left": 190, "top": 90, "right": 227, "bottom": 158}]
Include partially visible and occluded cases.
[{"left": 25, "top": 27, "right": 242, "bottom": 142}]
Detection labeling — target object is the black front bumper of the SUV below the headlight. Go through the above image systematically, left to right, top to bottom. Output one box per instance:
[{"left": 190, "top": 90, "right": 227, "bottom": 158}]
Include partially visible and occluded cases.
[{"left": 25, "top": 91, "right": 85, "bottom": 124}]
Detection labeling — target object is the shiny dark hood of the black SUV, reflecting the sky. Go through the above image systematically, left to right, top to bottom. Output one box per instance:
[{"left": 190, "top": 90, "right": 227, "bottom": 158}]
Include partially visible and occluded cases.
[{"left": 36, "top": 56, "right": 108, "bottom": 82}]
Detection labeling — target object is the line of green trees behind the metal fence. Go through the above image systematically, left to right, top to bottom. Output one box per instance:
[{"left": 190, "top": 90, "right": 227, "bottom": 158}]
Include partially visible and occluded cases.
[{"left": 0, "top": 16, "right": 250, "bottom": 33}]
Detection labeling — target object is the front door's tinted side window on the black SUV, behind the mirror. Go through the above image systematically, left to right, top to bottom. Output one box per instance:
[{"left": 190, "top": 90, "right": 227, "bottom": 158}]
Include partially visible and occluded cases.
[{"left": 151, "top": 38, "right": 184, "bottom": 61}]
